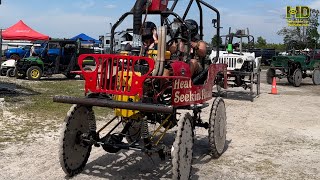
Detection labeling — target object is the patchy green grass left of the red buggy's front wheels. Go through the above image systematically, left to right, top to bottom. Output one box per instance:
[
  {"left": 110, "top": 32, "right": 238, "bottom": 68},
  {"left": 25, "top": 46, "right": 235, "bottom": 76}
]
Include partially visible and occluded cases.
[{"left": 0, "top": 80, "right": 112, "bottom": 143}]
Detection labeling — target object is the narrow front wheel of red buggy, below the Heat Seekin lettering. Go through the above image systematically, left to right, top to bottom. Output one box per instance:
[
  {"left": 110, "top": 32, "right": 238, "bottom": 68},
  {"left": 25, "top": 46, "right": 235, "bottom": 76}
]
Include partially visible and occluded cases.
[{"left": 171, "top": 113, "right": 193, "bottom": 180}]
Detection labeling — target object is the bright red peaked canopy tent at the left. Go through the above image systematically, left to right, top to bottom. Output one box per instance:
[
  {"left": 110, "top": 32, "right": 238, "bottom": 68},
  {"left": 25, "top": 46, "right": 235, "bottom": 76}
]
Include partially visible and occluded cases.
[{"left": 2, "top": 20, "right": 49, "bottom": 41}]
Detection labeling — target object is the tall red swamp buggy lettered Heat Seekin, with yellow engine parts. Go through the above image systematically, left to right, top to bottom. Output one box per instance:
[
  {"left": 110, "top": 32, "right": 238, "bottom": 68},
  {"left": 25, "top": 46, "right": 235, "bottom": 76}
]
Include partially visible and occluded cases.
[{"left": 53, "top": 0, "right": 227, "bottom": 179}]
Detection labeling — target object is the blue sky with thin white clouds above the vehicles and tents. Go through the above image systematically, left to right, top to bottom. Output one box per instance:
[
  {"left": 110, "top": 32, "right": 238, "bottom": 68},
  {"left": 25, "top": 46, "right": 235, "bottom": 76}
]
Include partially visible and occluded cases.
[{"left": 0, "top": 0, "right": 320, "bottom": 43}]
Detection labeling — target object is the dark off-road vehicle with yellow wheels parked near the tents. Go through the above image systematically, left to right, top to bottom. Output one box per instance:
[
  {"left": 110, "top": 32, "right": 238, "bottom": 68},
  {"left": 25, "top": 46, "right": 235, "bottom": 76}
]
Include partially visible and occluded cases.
[{"left": 15, "top": 40, "right": 93, "bottom": 80}]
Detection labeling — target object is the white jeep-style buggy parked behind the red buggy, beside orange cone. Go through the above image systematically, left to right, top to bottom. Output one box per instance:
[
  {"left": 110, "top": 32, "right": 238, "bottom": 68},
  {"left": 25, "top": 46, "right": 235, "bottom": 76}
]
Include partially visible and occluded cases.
[{"left": 209, "top": 28, "right": 261, "bottom": 100}]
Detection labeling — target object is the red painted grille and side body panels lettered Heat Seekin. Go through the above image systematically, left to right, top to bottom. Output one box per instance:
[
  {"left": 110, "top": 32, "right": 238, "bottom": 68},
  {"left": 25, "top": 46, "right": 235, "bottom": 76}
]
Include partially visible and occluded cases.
[{"left": 78, "top": 54, "right": 227, "bottom": 107}]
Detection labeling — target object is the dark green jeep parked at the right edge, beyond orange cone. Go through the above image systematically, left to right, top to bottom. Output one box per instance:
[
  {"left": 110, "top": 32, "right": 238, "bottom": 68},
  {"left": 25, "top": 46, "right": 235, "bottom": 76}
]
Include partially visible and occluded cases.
[{"left": 267, "top": 42, "right": 320, "bottom": 87}]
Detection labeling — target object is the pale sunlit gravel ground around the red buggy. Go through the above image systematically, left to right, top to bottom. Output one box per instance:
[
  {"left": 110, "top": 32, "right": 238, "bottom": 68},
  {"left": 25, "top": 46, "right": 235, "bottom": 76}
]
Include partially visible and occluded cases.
[{"left": 0, "top": 71, "right": 320, "bottom": 180}]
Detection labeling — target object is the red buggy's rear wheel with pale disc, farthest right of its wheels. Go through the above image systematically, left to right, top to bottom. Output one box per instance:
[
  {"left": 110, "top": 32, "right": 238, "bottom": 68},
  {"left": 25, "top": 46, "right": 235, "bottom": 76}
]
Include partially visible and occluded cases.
[{"left": 209, "top": 97, "right": 227, "bottom": 158}]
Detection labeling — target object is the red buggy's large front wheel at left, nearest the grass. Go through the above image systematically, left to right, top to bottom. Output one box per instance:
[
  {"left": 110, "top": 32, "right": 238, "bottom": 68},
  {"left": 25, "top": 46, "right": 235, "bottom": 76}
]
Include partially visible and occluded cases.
[{"left": 59, "top": 105, "right": 96, "bottom": 176}]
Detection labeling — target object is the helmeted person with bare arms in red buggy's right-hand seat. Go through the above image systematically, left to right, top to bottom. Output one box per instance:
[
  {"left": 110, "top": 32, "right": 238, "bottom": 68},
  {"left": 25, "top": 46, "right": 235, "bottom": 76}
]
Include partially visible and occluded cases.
[{"left": 164, "top": 19, "right": 207, "bottom": 77}]
